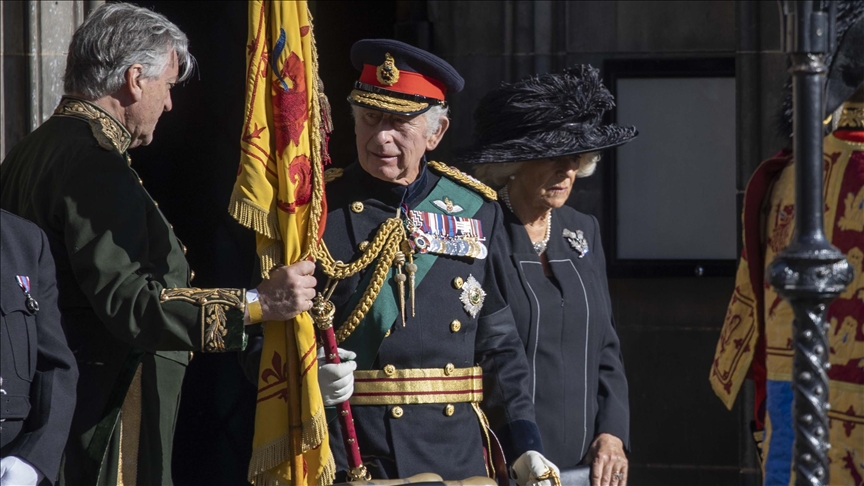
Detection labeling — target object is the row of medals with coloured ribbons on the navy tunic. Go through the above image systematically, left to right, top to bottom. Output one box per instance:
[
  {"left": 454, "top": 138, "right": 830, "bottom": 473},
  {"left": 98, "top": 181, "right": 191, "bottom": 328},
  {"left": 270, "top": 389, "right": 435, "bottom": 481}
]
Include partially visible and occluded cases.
[{"left": 407, "top": 211, "right": 489, "bottom": 259}]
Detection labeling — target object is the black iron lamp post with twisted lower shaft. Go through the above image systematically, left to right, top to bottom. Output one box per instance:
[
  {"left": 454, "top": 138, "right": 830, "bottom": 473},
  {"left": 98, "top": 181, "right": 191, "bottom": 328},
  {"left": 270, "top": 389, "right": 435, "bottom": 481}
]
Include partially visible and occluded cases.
[{"left": 766, "top": 1, "right": 852, "bottom": 486}]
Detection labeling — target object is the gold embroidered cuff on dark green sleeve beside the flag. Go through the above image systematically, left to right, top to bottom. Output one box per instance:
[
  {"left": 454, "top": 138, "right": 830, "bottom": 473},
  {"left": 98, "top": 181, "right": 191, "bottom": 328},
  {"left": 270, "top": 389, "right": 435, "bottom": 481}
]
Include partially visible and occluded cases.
[{"left": 159, "top": 288, "right": 246, "bottom": 353}]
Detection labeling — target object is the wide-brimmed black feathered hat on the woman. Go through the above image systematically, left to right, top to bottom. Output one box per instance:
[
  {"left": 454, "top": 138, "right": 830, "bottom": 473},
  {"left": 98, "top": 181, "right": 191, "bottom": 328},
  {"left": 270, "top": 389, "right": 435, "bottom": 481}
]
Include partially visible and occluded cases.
[{"left": 457, "top": 64, "right": 638, "bottom": 164}]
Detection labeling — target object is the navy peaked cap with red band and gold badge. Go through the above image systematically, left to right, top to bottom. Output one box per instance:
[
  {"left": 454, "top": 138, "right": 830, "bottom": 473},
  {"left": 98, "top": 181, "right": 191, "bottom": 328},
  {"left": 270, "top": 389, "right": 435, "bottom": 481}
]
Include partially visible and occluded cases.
[{"left": 348, "top": 39, "right": 465, "bottom": 115}]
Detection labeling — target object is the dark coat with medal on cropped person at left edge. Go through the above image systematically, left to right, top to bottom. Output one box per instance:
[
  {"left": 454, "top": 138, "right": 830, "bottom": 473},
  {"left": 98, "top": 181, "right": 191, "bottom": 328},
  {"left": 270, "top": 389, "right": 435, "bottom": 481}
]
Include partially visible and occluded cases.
[{"left": 0, "top": 211, "right": 78, "bottom": 482}]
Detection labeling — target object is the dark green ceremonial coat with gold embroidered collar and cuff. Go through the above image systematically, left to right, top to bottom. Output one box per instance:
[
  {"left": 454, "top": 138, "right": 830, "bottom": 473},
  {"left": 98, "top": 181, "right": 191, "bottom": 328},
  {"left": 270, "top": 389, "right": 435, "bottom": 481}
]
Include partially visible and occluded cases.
[{"left": 0, "top": 97, "right": 245, "bottom": 486}]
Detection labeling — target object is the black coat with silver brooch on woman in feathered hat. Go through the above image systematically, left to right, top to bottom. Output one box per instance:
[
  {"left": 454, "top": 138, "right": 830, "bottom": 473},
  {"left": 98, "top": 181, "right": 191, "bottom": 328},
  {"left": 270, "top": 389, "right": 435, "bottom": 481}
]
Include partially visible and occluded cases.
[{"left": 502, "top": 206, "right": 630, "bottom": 468}]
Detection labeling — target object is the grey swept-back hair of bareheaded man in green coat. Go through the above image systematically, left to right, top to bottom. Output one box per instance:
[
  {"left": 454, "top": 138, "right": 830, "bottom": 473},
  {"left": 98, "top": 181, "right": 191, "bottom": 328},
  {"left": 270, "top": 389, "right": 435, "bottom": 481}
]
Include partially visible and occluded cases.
[{"left": 63, "top": 3, "right": 195, "bottom": 100}]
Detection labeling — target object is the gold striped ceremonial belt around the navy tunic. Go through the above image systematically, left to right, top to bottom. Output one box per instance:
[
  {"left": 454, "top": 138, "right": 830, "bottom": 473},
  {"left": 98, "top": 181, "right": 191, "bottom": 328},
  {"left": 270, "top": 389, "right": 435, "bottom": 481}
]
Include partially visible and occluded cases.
[{"left": 350, "top": 365, "right": 483, "bottom": 405}]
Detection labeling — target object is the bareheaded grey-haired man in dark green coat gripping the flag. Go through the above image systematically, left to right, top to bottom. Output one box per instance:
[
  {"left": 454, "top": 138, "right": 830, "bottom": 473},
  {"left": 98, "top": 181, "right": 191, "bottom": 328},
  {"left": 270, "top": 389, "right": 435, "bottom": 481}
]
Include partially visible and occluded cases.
[{"left": 0, "top": 4, "right": 315, "bottom": 486}]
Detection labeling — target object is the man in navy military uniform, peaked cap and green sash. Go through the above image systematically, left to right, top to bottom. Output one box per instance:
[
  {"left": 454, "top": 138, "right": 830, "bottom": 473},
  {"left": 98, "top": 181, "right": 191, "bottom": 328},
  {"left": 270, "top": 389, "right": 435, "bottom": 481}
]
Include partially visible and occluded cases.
[{"left": 284, "top": 40, "right": 557, "bottom": 484}]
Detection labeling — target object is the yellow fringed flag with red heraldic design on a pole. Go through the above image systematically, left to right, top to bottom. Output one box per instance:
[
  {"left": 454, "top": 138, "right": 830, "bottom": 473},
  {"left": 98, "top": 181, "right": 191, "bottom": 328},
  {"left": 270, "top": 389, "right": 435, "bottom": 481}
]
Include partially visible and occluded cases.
[{"left": 229, "top": 0, "right": 335, "bottom": 486}]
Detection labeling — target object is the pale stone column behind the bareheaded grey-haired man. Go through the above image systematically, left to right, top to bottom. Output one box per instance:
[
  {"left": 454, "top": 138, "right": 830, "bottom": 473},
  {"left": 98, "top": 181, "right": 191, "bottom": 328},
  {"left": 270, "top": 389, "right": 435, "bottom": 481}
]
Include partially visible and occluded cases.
[{"left": 0, "top": 0, "right": 104, "bottom": 157}]
